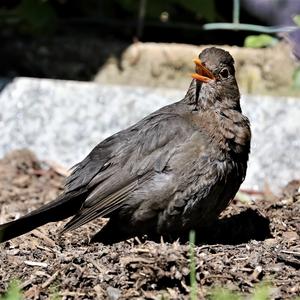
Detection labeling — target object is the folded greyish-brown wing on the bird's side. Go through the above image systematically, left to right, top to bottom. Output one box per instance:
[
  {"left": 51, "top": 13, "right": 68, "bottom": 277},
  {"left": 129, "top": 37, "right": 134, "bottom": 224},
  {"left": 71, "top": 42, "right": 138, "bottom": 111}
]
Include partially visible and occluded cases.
[{"left": 63, "top": 104, "right": 194, "bottom": 231}]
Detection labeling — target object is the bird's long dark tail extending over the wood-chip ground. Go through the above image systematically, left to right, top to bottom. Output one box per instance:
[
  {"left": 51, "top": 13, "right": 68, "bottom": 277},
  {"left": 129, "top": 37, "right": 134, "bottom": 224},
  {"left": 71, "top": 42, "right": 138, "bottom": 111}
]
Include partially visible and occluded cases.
[{"left": 0, "top": 194, "right": 82, "bottom": 243}]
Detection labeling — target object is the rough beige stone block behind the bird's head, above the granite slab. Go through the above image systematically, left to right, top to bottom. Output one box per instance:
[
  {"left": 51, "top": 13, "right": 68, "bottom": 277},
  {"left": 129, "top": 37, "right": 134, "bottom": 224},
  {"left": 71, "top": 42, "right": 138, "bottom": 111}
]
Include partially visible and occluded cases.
[{"left": 94, "top": 43, "right": 300, "bottom": 95}]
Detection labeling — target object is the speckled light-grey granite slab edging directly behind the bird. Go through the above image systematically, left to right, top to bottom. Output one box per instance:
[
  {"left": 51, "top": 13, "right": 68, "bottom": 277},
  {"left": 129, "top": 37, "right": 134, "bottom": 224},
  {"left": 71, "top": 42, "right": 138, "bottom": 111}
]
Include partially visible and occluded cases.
[{"left": 0, "top": 78, "right": 300, "bottom": 191}]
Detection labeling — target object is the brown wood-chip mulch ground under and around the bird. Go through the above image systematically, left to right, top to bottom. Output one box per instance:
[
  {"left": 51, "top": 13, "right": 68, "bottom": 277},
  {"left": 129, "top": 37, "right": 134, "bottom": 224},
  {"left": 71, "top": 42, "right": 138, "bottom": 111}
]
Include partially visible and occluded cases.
[{"left": 0, "top": 150, "right": 300, "bottom": 299}]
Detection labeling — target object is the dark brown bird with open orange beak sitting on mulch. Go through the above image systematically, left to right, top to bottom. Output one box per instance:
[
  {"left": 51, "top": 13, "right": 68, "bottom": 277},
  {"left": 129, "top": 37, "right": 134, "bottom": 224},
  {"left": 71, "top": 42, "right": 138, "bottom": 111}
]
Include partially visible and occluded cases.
[{"left": 0, "top": 47, "right": 251, "bottom": 244}]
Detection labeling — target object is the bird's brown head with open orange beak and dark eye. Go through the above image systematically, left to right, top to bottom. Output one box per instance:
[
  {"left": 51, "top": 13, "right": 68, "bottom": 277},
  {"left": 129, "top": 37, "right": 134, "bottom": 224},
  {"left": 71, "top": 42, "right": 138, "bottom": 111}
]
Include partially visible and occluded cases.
[{"left": 191, "top": 47, "right": 240, "bottom": 108}]
